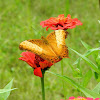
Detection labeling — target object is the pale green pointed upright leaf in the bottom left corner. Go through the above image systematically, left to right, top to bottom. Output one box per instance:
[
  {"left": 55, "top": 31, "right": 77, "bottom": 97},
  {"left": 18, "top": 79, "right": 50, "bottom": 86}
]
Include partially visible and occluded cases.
[{"left": 0, "top": 80, "right": 13, "bottom": 100}]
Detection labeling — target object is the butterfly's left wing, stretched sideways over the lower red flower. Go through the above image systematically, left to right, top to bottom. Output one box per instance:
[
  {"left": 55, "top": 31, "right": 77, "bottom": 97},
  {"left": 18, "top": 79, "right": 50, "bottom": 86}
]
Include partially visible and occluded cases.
[{"left": 19, "top": 39, "right": 59, "bottom": 63}]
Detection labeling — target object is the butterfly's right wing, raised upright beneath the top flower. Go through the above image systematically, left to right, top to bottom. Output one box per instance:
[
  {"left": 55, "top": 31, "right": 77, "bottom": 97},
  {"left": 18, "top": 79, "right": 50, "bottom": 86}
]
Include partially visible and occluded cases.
[{"left": 46, "top": 30, "right": 68, "bottom": 58}]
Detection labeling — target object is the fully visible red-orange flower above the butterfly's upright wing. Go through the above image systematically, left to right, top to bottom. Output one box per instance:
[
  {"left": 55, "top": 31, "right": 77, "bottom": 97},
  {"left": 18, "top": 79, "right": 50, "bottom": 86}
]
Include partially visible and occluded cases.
[{"left": 40, "top": 14, "right": 82, "bottom": 30}]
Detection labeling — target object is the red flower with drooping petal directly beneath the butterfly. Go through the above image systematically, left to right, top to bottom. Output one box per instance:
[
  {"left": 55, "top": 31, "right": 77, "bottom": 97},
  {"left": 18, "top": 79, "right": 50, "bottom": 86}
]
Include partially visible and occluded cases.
[{"left": 19, "top": 51, "right": 53, "bottom": 77}]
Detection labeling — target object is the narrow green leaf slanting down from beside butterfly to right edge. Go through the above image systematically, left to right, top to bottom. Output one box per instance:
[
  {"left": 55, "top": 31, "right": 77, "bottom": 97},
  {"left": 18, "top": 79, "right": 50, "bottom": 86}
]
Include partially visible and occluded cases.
[{"left": 70, "top": 48, "right": 100, "bottom": 73}]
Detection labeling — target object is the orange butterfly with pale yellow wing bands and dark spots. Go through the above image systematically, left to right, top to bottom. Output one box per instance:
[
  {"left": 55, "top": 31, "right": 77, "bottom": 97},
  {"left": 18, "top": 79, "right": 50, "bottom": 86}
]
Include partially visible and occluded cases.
[{"left": 19, "top": 30, "right": 68, "bottom": 63}]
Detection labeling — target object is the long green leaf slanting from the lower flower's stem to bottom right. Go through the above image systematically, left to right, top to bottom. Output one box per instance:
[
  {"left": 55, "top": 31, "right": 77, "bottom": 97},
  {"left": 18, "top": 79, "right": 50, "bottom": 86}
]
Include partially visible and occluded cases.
[{"left": 47, "top": 71, "right": 100, "bottom": 98}]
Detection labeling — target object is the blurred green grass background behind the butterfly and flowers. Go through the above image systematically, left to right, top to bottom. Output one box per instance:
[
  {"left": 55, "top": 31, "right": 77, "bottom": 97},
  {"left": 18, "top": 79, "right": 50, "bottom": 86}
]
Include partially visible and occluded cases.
[{"left": 0, "top": 0, "right": 100, "bottom": 100}]
